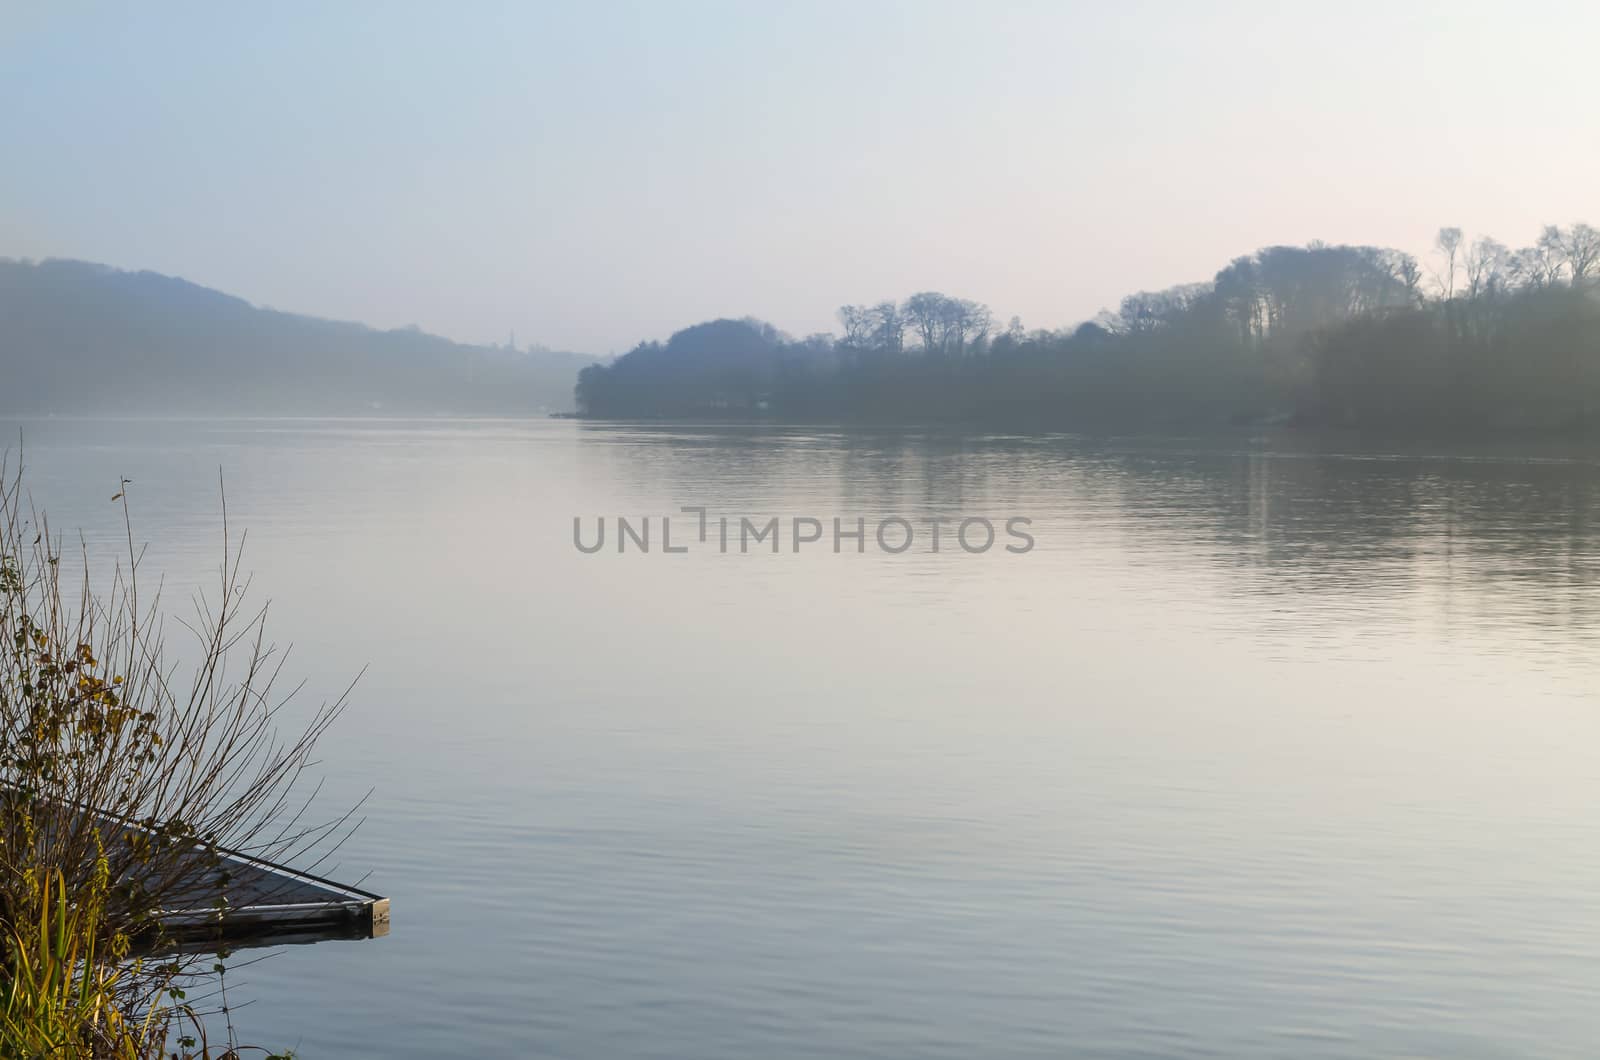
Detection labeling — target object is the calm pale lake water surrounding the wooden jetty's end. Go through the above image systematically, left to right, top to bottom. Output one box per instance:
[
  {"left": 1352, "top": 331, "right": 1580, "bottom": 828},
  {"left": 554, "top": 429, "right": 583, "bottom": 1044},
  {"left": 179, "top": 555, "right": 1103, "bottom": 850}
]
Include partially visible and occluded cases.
[{"left": 0, "top": 420, "right": 1600, "bottom": 1060}]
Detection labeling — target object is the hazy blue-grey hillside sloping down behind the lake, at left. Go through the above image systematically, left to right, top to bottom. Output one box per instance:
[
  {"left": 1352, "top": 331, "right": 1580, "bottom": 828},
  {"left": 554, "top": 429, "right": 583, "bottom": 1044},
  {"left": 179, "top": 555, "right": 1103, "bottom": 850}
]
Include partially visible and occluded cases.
[{"left": 0, "top": 259, "right": 594, "bottom": 415}]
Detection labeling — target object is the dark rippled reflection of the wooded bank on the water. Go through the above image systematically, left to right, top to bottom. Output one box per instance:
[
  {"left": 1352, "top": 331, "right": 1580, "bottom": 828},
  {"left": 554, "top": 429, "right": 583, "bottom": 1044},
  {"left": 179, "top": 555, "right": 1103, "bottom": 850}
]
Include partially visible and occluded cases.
[{"left": 578, "top": 424, "right": 1600, "bottom": 631}]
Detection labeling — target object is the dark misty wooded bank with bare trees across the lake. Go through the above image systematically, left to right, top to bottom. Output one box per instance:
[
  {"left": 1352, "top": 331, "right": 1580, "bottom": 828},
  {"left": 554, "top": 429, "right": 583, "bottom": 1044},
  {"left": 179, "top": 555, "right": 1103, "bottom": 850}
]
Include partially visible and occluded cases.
[{"left": 574, "top": 223, "right": 1600, "bottom": 436}]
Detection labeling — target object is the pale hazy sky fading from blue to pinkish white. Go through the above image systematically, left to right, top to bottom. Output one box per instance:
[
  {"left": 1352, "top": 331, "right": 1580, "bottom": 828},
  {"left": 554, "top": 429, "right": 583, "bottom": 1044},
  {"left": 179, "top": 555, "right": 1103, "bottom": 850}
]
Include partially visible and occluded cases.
[{"left": 0, "top": 0, "right": 1600, "bottom": 354}]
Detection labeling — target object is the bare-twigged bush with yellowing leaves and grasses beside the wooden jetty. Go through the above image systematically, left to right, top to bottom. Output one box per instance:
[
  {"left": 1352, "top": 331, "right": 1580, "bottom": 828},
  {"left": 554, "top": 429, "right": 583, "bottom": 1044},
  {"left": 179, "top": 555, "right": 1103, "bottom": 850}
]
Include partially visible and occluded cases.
[{"left": 0, "top": 461, "right": 352, "bottom": 1060}]
